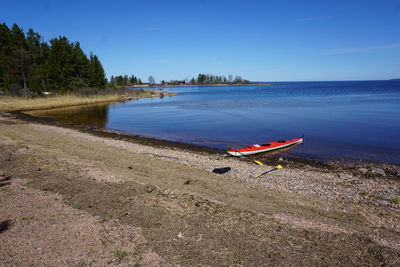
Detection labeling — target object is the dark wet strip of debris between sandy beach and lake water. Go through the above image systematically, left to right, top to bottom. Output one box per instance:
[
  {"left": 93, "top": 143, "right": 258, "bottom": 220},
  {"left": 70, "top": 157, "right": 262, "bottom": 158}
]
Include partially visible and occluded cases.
[{"left": 3, "top": 111, "right": 400, "bottom": 192}]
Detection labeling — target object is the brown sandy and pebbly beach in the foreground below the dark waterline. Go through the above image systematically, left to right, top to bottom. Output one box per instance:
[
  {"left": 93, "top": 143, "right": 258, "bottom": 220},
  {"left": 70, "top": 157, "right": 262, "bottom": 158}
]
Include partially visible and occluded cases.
[{"left": 0, "top": 108, "right": 400, "bottom": 266}]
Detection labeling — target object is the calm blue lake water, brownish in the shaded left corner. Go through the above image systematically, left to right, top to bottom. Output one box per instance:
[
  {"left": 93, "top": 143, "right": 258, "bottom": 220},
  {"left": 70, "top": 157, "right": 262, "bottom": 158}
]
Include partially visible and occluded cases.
[{"left": 32, "top": 81, "right": 400, "bottom": 163}]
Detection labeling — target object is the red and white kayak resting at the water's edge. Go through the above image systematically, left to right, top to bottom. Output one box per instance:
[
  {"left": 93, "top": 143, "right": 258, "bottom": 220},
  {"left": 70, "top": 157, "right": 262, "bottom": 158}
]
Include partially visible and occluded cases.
[{"left": 228, "top": 137, "right": 303, "bottom": 157}]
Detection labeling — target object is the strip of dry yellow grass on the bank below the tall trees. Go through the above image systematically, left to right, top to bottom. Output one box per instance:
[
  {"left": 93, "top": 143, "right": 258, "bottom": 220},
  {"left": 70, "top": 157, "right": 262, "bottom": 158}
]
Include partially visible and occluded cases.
[{"left": 0, "top": 91, "right": 167, "bottom": 112}]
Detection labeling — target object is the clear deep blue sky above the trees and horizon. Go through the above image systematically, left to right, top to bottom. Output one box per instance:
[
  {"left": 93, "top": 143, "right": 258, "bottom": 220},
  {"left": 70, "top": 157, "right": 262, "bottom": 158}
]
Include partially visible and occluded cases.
[{"left": 0, "top": 0, "right": 400, "bottom": 81}]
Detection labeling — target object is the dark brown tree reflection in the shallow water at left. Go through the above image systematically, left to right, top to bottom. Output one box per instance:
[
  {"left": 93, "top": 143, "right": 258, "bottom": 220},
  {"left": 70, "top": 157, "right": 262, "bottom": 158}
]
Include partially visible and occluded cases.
[{"left": 32, "top": 105, "right": 109, "bottom": 128}]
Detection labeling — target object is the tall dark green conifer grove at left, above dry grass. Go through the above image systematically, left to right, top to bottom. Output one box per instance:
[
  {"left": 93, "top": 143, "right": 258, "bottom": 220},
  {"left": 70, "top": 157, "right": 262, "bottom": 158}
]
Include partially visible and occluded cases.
[{"left": 0, "top": 23, "right": 107, "bottom": 95}]
